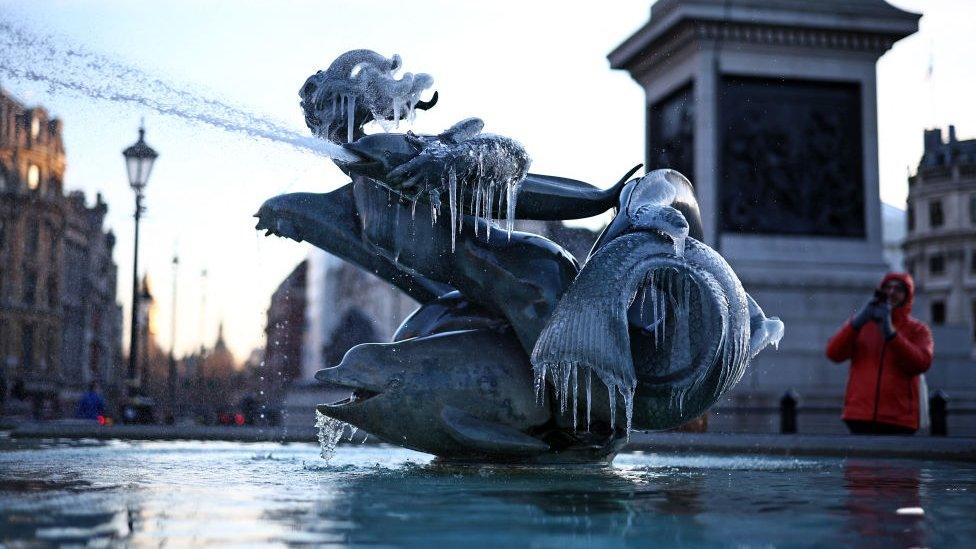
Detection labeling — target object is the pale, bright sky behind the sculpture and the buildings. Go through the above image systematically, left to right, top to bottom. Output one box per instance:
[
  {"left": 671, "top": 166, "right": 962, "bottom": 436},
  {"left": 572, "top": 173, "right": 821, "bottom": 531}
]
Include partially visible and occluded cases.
[{"left": 0, "top": 0, "right": 976, "bottom": 359}]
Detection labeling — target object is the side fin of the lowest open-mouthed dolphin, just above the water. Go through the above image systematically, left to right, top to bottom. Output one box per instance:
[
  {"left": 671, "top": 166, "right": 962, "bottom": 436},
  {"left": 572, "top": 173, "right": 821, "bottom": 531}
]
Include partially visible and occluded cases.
[{"left": 441, "top": 406, "right": 549, "bottom": 455}]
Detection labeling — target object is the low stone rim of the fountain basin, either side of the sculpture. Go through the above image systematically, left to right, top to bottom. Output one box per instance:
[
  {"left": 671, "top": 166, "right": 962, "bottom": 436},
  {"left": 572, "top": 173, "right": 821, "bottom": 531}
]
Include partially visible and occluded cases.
[{"left": 7, "top": 421, "right": 976, "bottom": 461}]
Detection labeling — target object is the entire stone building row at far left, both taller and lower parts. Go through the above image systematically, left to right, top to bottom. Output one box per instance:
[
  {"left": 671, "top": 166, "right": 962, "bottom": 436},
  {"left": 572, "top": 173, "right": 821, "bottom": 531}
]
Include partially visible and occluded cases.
[{"left": 0, "top": 86, "right": 121, "bottom": 416}]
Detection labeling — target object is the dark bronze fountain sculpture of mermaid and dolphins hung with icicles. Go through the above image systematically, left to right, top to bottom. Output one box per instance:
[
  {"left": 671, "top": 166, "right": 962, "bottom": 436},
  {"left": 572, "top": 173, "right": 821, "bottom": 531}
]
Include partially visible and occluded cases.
[{"left": 257, "top": 50, "right": 783, "bottom": 464}]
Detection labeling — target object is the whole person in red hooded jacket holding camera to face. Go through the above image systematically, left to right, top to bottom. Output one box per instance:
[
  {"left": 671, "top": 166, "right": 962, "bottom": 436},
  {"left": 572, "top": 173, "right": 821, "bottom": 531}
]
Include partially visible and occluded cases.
[{"left": 827, "top": 273, "right": 933, "bottom": 434}]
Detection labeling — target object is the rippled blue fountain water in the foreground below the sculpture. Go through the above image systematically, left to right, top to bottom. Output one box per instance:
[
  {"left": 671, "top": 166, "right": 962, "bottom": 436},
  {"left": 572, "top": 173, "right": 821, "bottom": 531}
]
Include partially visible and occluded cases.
[{"left": 0, "top": 440, "right": 976, "bottom": 548}]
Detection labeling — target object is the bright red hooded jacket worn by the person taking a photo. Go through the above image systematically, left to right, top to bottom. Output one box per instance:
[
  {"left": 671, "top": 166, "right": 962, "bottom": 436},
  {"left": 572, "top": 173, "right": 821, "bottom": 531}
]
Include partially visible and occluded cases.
[{"left": 827, "top": 273, "right": 933, "bottom": 429}]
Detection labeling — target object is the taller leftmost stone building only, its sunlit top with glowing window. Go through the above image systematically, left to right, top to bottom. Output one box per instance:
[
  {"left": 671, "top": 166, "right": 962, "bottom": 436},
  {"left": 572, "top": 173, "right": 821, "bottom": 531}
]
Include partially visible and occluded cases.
[{"left": 0, "top": 88, "right": 65, "bottom": 413}]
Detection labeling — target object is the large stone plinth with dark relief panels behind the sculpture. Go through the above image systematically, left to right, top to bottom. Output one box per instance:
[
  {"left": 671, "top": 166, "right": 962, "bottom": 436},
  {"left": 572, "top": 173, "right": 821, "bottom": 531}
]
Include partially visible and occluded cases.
[{"left": 609, "top": 0, "right": 920, "bottom": 424}]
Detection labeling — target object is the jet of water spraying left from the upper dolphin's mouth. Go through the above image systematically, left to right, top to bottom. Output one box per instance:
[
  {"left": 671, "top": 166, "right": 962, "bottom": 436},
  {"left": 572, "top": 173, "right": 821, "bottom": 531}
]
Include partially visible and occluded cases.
[{"left": 0, "top": 21, "right": 360, "bottom": 162}]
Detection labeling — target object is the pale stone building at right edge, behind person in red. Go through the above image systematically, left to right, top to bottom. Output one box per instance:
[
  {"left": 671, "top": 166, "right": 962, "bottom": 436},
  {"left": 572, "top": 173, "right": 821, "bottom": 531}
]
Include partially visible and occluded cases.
[{"left": 904, "top": 126, "right": 976, "bottom": 358}]
